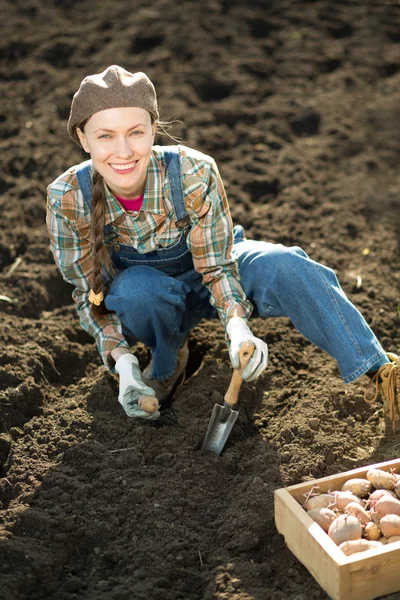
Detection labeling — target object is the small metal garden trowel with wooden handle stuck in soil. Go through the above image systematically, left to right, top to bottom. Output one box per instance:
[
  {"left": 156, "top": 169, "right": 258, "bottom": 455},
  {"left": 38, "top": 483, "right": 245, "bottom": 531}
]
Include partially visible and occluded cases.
[{"left": 203, "top": 342, "right": 254, "bottom": 456}]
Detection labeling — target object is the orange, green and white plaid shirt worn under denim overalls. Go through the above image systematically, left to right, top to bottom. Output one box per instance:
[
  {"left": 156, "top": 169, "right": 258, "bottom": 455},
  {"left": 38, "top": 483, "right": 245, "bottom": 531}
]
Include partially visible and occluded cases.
[{"left": 46, "top": 145, "right": 253, "bottom": 372}]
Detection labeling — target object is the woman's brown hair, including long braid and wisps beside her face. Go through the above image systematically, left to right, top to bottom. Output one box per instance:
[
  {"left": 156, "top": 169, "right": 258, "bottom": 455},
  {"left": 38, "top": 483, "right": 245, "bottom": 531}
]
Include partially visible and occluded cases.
[{"left": 75, "top": 117, "right": 181, "bottom": 317}]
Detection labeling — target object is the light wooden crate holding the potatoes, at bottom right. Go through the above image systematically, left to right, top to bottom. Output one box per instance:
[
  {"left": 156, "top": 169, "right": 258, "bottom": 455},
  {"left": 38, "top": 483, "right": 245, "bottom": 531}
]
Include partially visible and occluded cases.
[{"left": 275, "top": 459, "right": 400, "bottom": 600}]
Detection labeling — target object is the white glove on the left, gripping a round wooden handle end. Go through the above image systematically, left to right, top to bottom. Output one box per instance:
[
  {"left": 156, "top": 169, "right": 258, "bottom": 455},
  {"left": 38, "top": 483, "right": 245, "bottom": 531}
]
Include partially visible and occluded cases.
[{"left": 115, "top": 353, "right": 160, "bottom": 421}]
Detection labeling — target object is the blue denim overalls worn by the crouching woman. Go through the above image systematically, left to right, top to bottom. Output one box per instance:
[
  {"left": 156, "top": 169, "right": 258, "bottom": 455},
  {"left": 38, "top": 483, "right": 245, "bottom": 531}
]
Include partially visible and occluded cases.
[{"left": 77, "top": 146, "right": 387, "bottom": 383}]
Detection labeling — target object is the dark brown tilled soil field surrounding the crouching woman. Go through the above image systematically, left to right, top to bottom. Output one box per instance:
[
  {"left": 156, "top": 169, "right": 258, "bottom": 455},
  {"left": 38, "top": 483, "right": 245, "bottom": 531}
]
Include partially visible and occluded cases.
[{"left": 0, "top": 0, "right": 400, "bottom": 600}]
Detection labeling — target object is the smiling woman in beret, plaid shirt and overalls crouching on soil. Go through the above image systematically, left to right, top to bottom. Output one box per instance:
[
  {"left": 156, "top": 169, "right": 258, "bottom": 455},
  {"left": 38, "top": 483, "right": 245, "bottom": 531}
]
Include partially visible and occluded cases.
[{"left": 47, "top": 65, "right": 400, "bottom": 426}]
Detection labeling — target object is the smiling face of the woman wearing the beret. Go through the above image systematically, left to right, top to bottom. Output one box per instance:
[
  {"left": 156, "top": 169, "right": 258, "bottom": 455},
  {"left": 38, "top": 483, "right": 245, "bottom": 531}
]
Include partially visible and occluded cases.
[{"left": 77, "top": 107, "right": 157, "bottom": 199}]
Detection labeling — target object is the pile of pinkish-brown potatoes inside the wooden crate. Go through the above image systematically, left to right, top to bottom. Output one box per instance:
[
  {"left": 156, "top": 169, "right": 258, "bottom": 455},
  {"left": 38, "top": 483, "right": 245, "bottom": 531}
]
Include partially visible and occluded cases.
[{"left": 304, "top": 469, "right": 400, "bottom": 556}]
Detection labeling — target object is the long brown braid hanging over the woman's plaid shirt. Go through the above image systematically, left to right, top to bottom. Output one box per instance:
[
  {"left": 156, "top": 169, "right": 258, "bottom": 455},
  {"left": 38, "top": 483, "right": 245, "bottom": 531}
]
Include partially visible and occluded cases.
[{"left": 91, "top": 171, "right": 114, "bottom": 316}]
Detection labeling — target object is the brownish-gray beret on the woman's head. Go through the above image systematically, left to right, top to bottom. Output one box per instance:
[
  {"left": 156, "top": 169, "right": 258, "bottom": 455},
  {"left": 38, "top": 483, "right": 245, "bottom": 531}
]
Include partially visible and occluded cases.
[{"left": 67, "top": 65, "right": 159, "bottom": 146}]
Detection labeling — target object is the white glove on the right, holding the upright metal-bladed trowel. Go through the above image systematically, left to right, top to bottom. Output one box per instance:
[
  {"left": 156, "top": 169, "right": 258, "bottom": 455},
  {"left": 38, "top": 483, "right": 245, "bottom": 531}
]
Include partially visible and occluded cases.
[{"left": 226, "top": 317, "right": 268, "bottom": 381}]
